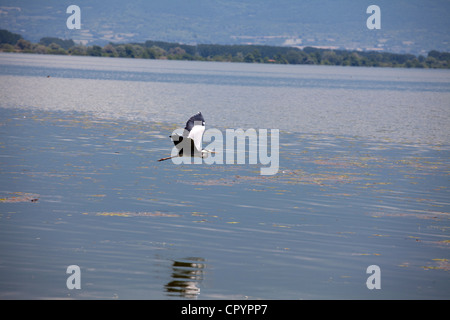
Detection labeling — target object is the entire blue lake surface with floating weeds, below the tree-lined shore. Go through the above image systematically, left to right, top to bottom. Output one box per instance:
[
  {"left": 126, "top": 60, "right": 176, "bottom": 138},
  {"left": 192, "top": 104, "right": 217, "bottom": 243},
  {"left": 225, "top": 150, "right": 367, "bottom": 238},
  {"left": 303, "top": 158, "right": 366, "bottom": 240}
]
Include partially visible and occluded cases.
[{"left": 0, "top": 54, "right": 450, "bottom": 299}]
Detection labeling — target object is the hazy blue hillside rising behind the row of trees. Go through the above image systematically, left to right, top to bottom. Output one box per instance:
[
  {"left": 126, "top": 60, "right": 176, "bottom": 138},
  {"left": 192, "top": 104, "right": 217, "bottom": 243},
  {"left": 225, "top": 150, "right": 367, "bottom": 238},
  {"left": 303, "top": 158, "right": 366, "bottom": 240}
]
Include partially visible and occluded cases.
[{"left": 0, "top": 0, "right": 450, "bottom": 54}]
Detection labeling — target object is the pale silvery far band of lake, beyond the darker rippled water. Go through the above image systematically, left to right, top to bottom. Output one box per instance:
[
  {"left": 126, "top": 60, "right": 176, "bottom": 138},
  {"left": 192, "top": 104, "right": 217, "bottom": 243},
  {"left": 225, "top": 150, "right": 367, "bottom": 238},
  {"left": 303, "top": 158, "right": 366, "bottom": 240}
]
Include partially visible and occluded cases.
[{"left": 0, "top": 54, "right": 450, "bottom": 144}]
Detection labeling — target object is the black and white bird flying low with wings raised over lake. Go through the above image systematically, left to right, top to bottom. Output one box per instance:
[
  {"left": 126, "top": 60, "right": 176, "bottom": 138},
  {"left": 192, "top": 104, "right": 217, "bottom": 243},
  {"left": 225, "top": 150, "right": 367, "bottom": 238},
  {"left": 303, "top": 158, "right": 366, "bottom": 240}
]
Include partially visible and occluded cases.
[{"left": 158, "top": 112, "right": 215, "bottom": 161}]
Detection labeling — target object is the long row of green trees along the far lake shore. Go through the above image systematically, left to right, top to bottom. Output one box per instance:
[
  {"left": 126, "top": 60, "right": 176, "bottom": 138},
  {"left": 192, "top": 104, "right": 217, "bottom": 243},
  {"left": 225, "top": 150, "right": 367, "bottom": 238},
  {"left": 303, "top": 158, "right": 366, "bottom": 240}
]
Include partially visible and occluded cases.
[{"left": 0, "top": 30, "right": 450, "bottom": 68}]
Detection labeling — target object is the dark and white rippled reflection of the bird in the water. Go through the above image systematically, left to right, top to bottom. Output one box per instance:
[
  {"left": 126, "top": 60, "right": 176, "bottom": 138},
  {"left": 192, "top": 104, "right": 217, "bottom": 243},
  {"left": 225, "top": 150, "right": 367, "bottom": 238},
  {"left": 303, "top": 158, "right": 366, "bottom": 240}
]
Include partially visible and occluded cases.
[{"left": 165, "top": 257, "right": 206, "bottom": 299}]
